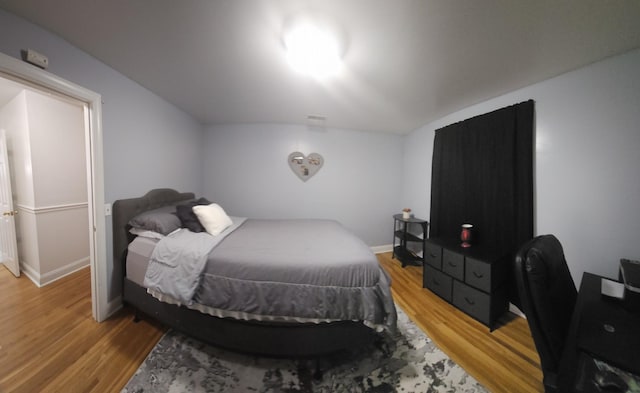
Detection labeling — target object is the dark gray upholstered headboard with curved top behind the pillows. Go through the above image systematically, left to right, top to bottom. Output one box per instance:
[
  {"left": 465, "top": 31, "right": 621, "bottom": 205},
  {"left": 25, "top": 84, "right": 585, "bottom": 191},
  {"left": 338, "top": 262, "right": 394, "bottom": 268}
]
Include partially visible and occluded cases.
[{"left": 113, "top": 188, "right": 195, "bottom": 273}]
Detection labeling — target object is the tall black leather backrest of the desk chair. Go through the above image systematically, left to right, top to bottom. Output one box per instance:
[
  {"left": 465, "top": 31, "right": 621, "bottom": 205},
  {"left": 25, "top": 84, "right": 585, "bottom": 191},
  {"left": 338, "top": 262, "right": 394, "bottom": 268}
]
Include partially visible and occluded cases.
[{"left": 515, "top": 235, "right": 577, "bottom": 393}]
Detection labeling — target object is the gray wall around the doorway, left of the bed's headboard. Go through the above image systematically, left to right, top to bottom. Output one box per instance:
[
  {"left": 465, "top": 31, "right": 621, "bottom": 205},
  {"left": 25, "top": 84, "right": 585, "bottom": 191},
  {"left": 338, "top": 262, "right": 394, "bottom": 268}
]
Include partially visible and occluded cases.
[{"left": 0, "top": 10, "right": 203, "bottom": 300}]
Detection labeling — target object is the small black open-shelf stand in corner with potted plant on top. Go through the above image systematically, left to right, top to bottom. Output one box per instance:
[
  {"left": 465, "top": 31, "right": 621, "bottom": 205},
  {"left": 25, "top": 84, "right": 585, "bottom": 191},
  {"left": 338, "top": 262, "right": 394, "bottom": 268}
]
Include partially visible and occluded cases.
[{"left": 391, "top": 214, "right": 429, "bottom": 267}]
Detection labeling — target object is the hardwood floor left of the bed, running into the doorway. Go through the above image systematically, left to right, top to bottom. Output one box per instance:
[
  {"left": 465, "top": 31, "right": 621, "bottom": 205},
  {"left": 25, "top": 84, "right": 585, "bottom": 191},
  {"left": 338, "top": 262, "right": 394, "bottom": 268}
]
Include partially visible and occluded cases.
[{"left": 0, "top": 266, "right": 164, "bottom": 393}]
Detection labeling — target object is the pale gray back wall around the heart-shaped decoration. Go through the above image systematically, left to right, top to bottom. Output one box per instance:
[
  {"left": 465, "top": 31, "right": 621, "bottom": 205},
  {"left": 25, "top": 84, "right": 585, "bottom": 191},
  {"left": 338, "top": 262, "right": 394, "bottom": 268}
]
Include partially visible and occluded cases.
[{"left": 204, "top": 124, "right": 402, "bottom": 246}]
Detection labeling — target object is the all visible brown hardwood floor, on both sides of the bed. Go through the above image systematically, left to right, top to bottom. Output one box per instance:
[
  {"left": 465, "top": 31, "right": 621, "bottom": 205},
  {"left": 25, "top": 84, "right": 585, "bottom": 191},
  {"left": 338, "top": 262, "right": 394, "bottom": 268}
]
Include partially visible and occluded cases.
[{"left": 0, "top": 253, "right": 543, "bottom": 393}]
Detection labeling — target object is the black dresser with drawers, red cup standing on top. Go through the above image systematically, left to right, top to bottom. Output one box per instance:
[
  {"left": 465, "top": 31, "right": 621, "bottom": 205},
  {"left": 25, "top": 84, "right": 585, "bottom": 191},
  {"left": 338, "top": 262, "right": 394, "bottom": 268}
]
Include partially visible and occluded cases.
[{"left": 423, "top": 238, "right": 511, "bottom": 330}]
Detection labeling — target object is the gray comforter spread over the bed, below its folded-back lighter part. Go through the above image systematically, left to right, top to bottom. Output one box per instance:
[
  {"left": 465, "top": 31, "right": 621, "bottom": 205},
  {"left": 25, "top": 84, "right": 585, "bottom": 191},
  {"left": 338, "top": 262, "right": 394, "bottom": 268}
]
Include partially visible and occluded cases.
[{"left": 145, "top": 219, "right": 396, "bottom": 330}]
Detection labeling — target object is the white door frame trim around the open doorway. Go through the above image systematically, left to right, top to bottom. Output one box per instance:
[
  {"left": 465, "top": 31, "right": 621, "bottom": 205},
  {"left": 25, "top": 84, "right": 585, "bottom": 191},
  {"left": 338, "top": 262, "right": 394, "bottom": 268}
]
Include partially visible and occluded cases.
[{"left": 0, "top": 52, "right": 107, "bottom": 322}]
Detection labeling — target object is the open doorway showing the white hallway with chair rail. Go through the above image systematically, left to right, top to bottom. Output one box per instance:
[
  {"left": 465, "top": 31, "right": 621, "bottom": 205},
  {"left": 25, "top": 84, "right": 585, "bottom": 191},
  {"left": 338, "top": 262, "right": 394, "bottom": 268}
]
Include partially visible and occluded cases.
[{"left": 0, "top": 77, "right": 90, "bottom": 286}]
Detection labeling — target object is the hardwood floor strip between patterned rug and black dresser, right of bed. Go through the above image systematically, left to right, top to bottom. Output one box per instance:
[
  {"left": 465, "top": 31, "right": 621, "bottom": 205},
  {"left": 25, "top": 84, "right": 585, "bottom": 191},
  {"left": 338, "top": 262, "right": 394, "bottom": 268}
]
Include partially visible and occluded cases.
[{"left": 378, "top": 253, "right": 544, "bottom": 393}]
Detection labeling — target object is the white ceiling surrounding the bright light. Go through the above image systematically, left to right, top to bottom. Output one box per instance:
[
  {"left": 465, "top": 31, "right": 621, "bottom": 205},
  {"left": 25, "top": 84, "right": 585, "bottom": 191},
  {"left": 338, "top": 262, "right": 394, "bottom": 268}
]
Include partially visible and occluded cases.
[{"left": 0, "top": 0, "right": 640, "bottom": 133}]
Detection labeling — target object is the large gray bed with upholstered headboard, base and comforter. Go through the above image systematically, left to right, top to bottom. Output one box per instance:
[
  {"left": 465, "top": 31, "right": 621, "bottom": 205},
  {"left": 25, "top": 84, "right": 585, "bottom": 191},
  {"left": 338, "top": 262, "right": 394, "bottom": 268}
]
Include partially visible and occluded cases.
[{"left": 113, "top": 189, "right": 396, "bottom": 357}]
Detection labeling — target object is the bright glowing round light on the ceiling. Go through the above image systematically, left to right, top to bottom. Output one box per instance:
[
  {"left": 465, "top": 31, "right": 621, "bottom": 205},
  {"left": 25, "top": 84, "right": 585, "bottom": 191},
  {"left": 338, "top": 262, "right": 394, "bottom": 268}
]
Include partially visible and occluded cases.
[{"left": 284, "top": 21, "right": 342, "bottom": 78}]
